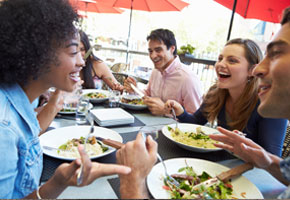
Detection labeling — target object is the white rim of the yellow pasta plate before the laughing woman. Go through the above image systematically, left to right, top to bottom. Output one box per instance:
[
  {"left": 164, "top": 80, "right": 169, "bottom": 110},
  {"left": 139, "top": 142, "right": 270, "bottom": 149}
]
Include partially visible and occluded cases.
[{"left": 162, "top": 123, "right": 221, "bottom": 152}]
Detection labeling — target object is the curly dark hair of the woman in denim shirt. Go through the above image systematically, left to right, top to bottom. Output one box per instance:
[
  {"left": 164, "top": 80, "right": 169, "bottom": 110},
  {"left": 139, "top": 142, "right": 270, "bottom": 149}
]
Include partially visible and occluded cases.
[{"left": 0, "top": 0, "right": 77, "bottom": 85}]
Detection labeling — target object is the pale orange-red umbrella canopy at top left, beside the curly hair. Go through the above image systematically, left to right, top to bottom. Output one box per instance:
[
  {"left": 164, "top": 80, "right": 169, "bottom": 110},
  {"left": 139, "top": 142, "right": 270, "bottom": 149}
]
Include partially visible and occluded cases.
[{"left": 69, "top": 0, "right": 124, "bottom": 14}]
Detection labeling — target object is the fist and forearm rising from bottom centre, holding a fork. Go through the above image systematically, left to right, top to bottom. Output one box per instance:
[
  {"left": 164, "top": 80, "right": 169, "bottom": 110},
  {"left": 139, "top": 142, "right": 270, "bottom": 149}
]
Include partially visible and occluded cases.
[{"left": 117, "top": 133, "right": 157, "bottom": 199}]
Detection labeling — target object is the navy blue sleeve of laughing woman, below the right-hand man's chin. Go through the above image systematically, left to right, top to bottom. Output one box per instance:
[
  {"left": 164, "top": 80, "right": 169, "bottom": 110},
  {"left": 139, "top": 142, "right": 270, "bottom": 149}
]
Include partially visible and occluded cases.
[{"left": 258, "top": 118, "right": 287, "bottom": 157}]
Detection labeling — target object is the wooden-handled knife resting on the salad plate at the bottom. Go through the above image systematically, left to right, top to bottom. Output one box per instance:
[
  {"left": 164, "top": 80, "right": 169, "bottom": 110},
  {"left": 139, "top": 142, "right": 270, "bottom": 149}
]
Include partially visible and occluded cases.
[{"left": 192, "top": 163, "right": 254, "bottom": 190}]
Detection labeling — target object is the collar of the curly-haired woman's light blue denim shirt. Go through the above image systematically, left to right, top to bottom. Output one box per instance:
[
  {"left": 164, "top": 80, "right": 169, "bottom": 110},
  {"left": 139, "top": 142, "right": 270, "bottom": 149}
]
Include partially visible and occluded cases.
[{"left": 2, "top": 84, "right": 41, "bottom": 135}]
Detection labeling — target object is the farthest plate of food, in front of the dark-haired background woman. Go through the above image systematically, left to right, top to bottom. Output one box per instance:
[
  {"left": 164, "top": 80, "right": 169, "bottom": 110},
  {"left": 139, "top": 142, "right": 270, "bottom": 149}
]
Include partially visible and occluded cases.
[{"left": 82, "top": 89, "right": 109, "bottom": 103}]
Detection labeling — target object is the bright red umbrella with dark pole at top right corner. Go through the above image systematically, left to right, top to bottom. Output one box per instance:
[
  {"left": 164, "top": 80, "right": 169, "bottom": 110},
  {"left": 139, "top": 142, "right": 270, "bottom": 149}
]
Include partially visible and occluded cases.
[{"left": 214, "top": 0, "right": 290, "bottom": 40}]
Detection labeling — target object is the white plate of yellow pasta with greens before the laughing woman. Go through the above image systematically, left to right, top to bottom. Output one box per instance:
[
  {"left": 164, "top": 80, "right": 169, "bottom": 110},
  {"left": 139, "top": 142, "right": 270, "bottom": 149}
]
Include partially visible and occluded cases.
[{"left": 162, "top": 123, "right": 221, "bottom": 152}]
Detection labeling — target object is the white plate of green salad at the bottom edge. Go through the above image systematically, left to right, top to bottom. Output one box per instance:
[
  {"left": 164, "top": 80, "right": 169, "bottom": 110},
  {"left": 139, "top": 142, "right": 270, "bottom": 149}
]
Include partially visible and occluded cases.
[{"left": 146, "top": 158, "right": 263, "bottom": 199}]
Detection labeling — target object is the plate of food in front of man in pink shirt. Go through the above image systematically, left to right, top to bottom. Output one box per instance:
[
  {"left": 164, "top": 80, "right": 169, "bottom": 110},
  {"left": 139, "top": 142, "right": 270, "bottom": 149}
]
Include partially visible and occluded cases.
[{"left": 120, "top": 94, "right": 147, "bottom": 110}]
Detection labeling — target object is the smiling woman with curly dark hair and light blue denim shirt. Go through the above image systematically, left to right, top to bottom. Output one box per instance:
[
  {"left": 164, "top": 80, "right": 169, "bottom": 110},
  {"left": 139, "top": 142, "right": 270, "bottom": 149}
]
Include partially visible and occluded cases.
[{"left": 0, "top": 0, "right": 130, "bottom": 199}]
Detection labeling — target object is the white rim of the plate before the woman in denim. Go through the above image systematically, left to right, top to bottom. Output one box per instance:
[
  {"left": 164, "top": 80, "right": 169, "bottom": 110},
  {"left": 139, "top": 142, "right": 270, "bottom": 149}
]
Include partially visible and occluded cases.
[{"left": 39, "top": 126, "right": 123, "bottom": 160}]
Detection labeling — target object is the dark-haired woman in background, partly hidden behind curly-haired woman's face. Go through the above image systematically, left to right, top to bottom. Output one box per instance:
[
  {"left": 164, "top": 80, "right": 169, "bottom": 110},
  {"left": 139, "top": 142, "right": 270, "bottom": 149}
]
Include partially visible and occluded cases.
[{"left": 80, "top": 30, "right": 123, "bottom": 91}]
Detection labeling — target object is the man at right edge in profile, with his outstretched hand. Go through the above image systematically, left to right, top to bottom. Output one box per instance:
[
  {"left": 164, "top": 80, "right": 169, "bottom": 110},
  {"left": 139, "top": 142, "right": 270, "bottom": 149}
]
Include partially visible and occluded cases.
[{"left": 210, "top": 7, "right": 290, "bottom": 199}]
